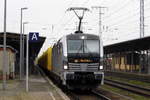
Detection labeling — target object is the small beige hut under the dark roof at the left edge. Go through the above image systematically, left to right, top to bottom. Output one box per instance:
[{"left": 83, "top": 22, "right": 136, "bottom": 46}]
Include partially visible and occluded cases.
[{"left": 0, "top": 45, "right": 16, "bottom": 80}]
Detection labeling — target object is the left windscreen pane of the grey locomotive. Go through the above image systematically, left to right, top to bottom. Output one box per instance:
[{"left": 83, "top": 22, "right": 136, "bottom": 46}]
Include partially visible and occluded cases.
[{"left": 68, "top": 40, "right": 83, "bottom": 53}]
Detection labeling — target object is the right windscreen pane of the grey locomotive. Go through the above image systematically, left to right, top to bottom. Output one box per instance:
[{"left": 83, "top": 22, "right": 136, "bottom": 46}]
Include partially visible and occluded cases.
[{"left": 84, "top": 40, "right": 99, "bottom": 53}]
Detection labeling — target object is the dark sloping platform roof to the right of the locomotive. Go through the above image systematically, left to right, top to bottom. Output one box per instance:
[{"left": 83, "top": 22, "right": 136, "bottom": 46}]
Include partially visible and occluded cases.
[{"left": 104, "top": 36, "right": 150, "bottom": 54}]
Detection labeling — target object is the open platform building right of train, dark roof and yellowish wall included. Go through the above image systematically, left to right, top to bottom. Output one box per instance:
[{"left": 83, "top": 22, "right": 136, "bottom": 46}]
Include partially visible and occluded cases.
[{"left": 104, "top": 37, "right": 150, "bottom": 74}]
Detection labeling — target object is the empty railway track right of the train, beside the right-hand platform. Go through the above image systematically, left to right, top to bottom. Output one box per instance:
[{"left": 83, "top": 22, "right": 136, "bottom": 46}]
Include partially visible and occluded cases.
[{"left": 104, "top": 79, "right": 150, "bottom": 97}]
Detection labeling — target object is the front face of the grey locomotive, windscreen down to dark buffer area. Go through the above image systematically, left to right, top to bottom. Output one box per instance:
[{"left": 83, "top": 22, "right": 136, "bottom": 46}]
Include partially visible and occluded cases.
[{"left": 63, "top": 34, "right": 104, "bottom": 89}]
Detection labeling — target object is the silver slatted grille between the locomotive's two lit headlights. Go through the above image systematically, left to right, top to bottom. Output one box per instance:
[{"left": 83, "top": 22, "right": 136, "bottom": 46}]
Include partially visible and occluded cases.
[{"left": 68, "top": 63, "right": 99, "bottom": 71}]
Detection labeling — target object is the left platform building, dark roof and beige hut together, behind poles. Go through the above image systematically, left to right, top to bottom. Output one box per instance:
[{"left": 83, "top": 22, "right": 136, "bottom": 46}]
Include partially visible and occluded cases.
[{"left": 0, "top": 32, "right": 46, "bottom": 77}]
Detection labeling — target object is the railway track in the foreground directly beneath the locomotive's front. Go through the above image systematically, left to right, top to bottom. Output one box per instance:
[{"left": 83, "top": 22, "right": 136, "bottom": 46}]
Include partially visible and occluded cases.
[{"left": 67, "top": 88, "right": 133, "bottom": 100}]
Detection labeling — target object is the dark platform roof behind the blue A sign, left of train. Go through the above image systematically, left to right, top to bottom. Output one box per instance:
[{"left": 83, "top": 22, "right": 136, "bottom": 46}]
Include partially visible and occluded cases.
[{"left": 0, "top": 32, "right": 46, "bottom": 57}]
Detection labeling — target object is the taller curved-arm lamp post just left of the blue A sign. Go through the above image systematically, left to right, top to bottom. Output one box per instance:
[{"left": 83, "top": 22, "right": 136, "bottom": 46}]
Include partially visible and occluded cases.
[{"left": 20, "top": 7, "right": 28, "bottom": 80}]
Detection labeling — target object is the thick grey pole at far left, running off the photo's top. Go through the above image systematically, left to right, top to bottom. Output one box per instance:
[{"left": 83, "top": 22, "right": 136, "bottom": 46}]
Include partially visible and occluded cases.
[{"left": 3, "top": 0, "right": 7, "bottom": 90}]
